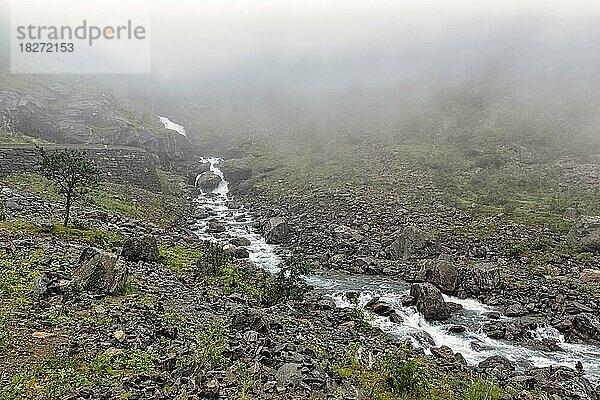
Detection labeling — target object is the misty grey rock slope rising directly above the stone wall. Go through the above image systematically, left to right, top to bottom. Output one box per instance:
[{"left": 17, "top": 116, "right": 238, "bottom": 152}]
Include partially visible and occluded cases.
[{"left": 0, "top": 89, "right": 191, "bottom": 159}]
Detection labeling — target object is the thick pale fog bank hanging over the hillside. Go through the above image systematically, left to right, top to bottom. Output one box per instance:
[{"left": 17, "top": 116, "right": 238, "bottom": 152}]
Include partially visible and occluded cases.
[{"left": 3, "top": 0, "right": 600, "bottom": 143}]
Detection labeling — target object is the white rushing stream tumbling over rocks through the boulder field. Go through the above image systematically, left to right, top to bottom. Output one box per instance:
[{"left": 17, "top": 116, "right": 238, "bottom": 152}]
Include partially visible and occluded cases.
[{"left": 186, "top": 139, "right": 600, "bottom": 384}]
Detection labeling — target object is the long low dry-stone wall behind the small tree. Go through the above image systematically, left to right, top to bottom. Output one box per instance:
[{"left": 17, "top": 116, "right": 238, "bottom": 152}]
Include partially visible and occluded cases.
[{"left": 0, "top": 145, "right": 160, "bottom": 191}]
